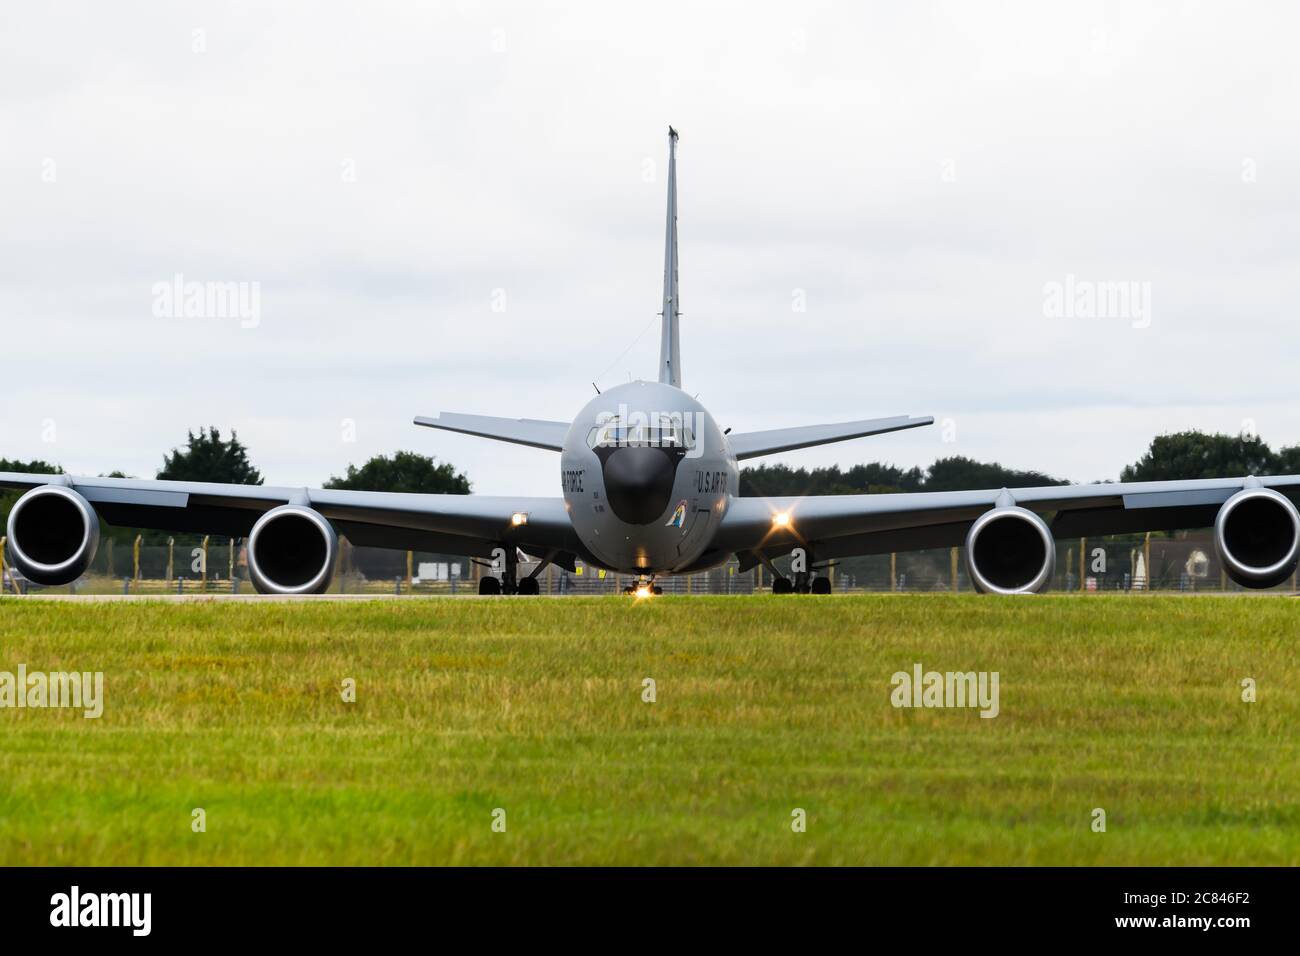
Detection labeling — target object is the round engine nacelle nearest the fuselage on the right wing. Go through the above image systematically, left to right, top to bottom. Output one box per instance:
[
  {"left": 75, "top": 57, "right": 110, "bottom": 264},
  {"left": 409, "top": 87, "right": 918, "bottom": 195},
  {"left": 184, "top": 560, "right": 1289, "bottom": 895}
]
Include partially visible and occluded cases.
[{"left": 966, "top": 507, "right": 1056, "bottom": 594}]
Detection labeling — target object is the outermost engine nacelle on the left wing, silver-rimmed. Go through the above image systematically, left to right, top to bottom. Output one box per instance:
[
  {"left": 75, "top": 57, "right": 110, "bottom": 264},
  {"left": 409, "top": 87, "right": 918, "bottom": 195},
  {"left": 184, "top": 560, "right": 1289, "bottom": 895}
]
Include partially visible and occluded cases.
[{"left": 7, "top": 485, "right": 99, "bottom": 587}]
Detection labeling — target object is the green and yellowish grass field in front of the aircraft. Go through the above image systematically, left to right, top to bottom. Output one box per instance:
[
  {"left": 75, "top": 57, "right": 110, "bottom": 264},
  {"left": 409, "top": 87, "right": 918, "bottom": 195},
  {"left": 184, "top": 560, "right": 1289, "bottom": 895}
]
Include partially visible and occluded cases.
[{"left": 0, "top": 594, "right": 1300, "bottom": 865}]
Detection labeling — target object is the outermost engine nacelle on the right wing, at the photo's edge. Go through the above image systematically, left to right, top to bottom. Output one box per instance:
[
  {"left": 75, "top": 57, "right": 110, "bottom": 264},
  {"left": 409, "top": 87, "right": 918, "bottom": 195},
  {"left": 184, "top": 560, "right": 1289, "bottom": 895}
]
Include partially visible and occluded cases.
[{"left": 1214, "top": 488, "right": 1300, "bottom": 588}]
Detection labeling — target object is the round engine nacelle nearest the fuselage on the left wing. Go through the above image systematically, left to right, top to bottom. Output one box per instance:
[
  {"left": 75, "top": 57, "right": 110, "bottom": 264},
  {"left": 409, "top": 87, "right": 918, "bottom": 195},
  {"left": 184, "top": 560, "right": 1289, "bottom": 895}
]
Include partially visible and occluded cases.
[{"left": 248, "top": 505, "right": 338, "bottom": 594}]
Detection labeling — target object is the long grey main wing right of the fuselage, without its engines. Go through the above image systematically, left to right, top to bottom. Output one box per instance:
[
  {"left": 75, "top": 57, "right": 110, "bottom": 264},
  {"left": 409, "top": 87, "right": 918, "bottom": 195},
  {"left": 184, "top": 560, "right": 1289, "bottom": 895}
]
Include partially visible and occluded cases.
[{"left": 715, "top": 475, "right": 1300, "bottom": 566}]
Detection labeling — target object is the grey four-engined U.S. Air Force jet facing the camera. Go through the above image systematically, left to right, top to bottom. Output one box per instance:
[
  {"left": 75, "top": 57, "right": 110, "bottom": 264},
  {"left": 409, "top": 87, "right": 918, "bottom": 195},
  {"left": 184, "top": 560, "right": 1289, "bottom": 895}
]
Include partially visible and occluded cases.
[{"left": 0, "top": 126, "right": 1300, "bottom": 594}]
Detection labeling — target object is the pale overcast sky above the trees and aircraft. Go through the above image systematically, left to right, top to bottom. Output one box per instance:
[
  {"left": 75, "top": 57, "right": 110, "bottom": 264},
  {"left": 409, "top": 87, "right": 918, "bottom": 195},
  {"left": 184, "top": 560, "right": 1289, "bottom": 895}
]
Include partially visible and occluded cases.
[{"left": 0, "top": 0, "right": 1300, "bottom": 494}]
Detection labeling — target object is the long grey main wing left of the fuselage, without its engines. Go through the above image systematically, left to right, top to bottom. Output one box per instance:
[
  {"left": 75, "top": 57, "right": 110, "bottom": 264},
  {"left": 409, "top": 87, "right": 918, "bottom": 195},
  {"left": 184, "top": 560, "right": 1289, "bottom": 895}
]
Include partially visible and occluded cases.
[{"left": 0, "top": 472, "right": 577, "bottom": 566}]
